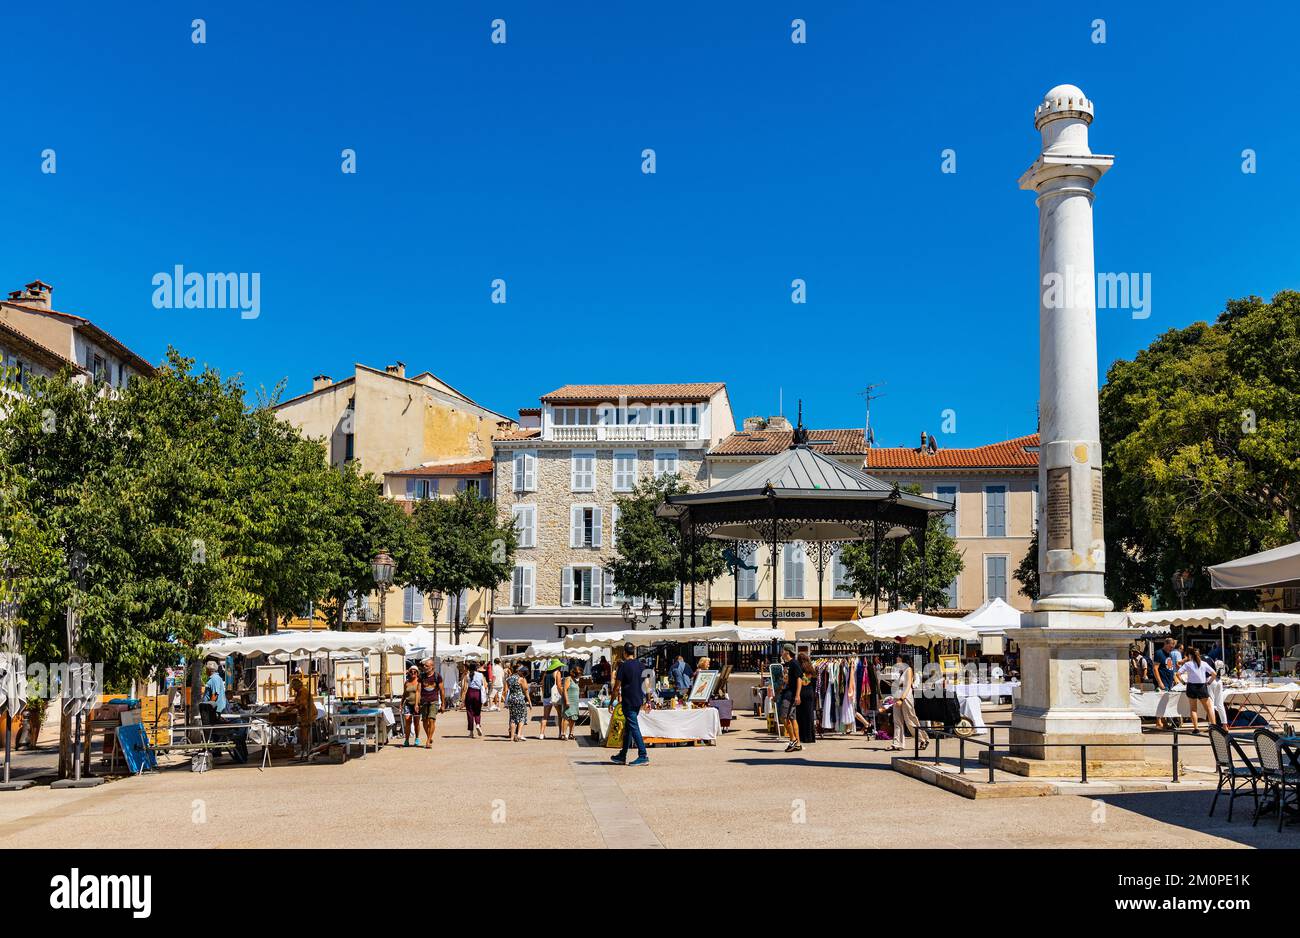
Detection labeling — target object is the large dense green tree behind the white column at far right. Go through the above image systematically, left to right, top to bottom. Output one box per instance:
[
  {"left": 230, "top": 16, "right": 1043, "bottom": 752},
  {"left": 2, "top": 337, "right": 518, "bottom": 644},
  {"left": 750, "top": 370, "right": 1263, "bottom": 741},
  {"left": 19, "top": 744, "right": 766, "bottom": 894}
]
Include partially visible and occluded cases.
[{"left": 1017, "top": 291, "right": 1300, "bottom": 609}]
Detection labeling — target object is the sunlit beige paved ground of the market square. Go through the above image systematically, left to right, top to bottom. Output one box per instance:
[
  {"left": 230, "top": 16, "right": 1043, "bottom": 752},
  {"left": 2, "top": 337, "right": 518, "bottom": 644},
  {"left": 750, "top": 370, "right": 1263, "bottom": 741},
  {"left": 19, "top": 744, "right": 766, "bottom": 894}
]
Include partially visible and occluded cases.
[{"left": 0, "top": 712, "right": 1279, "bottom": 848}]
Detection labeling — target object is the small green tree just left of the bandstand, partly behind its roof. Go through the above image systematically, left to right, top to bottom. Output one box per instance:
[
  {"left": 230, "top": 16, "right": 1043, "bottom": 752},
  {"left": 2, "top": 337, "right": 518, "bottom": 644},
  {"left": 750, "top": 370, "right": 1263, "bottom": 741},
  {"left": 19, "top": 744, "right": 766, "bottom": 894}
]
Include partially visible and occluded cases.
[{"left": 603, "top": 474, "right": 727, "bottom": 627}]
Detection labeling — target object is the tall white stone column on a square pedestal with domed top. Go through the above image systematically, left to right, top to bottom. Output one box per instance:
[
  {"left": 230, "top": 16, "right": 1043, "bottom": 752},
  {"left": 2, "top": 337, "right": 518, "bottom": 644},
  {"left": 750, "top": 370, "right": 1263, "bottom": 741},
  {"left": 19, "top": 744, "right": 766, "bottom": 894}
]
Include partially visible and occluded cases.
[{"left": 1000, "top": 84, "right": 1149, "bottom": 776}]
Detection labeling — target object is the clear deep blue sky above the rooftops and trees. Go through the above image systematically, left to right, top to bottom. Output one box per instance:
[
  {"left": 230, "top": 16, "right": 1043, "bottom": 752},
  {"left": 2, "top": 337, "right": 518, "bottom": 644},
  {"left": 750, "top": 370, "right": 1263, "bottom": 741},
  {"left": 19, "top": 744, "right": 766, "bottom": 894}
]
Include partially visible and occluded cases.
[{"left": 0, "top": 0, "right": 1300, "bottom": 446}]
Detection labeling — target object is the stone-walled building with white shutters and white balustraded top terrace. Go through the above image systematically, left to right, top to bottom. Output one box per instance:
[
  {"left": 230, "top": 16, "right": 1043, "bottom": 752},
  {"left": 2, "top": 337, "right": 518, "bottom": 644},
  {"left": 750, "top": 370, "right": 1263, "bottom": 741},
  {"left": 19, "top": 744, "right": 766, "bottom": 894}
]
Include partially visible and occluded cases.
[{"left": 493, "top": 383, "right": 735, "bottom": 653}]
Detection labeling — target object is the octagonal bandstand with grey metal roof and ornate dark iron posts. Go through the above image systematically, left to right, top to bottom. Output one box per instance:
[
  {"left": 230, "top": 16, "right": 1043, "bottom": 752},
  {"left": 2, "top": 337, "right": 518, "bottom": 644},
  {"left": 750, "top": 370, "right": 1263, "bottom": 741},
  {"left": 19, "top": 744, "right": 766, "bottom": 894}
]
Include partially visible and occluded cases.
[{"left": 658, "top": 421, "right": 952, "bottom": 627}]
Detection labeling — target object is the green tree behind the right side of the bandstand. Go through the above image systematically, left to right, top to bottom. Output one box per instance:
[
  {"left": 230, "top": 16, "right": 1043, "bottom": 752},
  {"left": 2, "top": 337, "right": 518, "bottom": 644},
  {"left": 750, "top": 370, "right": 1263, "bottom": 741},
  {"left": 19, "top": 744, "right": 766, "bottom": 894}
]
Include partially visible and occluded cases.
[{"left": 840, "top": 485, "right": 966, "bottom": 609}]
